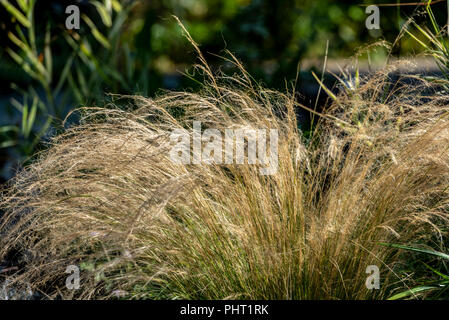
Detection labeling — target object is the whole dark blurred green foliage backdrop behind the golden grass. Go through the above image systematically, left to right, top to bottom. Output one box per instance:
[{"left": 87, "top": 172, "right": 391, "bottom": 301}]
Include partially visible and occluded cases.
[{"left": 0, "top": 0, "right": 447, "bottom": 177}]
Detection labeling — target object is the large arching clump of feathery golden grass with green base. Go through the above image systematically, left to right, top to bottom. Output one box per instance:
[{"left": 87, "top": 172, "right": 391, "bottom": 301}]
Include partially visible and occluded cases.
[{"left": 0, "top": 41, "right": 449, "bottom": 299}]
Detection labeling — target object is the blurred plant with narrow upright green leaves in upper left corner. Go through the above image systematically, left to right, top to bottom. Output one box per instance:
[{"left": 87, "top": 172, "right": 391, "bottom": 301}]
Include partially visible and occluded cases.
[{"left": 0, "top": 0, "right": 145, "bottom": 178}]
